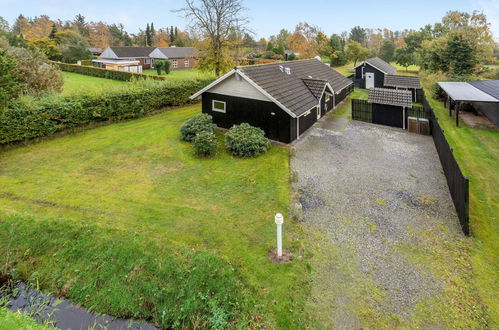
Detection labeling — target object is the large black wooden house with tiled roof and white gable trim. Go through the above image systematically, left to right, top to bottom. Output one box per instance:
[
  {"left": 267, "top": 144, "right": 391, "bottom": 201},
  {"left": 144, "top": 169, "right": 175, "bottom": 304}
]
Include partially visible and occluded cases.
[{"left": 191, "top": 59, "right": 353, "bottom": 143}]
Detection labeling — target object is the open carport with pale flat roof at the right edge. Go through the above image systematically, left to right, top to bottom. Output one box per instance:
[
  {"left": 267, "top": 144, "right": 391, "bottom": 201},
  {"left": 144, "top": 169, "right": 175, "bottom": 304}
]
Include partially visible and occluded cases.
[{"left": 438, "top": 80, "right": 499, "bottom": 126}]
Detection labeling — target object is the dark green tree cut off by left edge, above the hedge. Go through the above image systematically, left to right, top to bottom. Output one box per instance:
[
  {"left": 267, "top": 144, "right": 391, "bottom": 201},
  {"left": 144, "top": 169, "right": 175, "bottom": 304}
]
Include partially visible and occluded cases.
[{"left": 0, "top": 51, "right": 20, "bottom": 111}]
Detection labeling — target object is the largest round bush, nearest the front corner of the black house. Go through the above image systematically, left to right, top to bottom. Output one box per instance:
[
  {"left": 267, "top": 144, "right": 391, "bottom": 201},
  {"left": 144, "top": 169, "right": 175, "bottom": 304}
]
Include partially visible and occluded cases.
[{"left": 225, "top": 123, "right": 270, "bottom": 157}]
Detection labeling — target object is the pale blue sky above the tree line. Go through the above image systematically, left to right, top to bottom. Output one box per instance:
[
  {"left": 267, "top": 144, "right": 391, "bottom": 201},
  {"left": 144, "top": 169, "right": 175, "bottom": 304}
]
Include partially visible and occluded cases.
[{"left": 0, "top": 0, "right": 499, "bottom": 40}]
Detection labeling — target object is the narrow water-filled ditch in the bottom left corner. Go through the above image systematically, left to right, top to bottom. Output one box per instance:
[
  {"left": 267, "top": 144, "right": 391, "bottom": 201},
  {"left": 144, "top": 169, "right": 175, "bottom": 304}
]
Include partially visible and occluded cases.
[{"left": 0, "top": 273, "right": 159, "bottom": 330}]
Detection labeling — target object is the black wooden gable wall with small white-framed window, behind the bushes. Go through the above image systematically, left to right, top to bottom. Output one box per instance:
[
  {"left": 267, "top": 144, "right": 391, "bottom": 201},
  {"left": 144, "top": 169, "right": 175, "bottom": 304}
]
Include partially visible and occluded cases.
[{"left": 202, "top": 92, "right": 296, "bottom": 143}]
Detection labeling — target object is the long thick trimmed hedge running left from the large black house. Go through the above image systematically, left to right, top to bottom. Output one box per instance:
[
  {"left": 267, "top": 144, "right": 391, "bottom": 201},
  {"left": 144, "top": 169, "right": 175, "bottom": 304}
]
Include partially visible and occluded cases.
[{"left": 0, "top": 79, "right": 212, "bottom": 145}]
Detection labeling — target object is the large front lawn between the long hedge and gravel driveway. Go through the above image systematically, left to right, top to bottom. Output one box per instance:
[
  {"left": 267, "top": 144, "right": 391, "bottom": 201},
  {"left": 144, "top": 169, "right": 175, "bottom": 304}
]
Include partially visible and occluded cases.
[{"left": 0, "top": 105, "right": 308, "bottom": 328}]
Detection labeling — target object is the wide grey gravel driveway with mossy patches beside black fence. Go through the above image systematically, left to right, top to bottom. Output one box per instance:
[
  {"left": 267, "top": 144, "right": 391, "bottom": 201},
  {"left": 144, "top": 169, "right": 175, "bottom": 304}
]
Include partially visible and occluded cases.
[{"left": 291, "top": 118, "right": 484, "bottom": 328}]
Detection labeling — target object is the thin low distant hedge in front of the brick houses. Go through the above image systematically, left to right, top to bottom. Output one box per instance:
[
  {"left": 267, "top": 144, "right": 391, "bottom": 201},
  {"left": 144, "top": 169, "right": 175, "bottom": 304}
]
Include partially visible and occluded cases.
[{"left": 52, "top": 62, "right": 167, "bottom": 81}]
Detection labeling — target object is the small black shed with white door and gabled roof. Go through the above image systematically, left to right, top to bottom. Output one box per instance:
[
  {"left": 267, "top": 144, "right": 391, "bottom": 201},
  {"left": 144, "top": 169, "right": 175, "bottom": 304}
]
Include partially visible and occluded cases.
[{"left": 354, "top": 57, "right": 397, "bottom": 89}]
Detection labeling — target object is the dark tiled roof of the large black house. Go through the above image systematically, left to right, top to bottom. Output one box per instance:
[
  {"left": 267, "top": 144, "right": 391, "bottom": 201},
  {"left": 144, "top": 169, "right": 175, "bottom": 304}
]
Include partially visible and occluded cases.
[{"left": 238, "top": 59, "right": 352, "bottom": 116}]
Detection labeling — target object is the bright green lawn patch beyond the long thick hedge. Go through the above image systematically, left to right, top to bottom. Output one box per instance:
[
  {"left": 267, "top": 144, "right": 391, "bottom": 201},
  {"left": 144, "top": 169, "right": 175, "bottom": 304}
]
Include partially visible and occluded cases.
[{"left": 62, "top": 72, "right": 126, "bottom": 95}]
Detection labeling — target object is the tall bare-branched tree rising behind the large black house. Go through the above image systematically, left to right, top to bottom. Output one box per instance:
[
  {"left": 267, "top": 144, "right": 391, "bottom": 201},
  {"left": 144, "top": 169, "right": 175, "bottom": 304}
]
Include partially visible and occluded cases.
[{"left": 176, "top": 0, "right": 249, "bottom": 75}]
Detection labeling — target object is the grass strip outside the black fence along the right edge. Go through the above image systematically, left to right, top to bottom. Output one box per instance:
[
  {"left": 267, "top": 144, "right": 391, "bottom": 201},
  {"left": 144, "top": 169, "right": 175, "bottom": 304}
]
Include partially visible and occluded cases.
[{"left": 426, "top": 86, "right": 499, "bottom": 329}]
